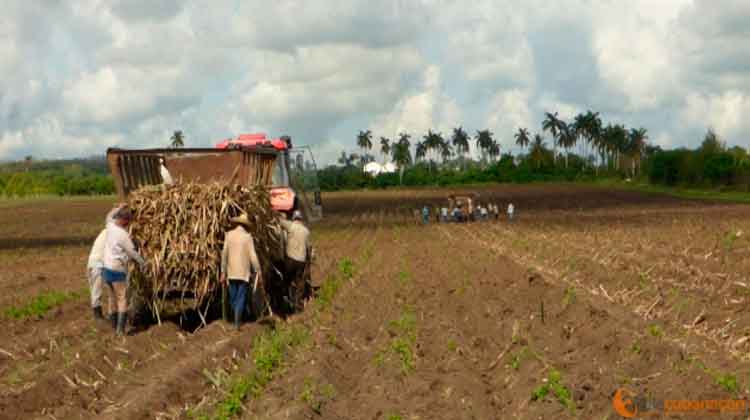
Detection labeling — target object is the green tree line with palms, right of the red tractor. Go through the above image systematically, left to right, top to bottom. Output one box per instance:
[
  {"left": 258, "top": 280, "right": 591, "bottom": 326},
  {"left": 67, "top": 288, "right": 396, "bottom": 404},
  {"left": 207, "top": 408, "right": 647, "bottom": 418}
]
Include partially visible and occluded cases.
[{"left": 318, "top": 111, "right": 750, "bottom": 190}]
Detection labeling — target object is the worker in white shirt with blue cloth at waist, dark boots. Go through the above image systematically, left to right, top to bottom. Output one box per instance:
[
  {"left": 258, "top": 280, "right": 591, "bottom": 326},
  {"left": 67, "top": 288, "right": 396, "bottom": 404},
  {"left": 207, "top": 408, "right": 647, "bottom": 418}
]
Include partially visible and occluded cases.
[{"left": 102, "top": 206, "right": 146, "bottom": 335}]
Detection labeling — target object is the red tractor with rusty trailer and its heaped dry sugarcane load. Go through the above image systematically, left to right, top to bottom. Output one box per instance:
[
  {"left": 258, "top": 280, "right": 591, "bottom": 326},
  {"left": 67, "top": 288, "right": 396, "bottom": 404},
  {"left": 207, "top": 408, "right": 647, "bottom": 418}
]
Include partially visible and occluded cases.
[{"left": 107, "top": 135, "right": 322, "bottom": 330}]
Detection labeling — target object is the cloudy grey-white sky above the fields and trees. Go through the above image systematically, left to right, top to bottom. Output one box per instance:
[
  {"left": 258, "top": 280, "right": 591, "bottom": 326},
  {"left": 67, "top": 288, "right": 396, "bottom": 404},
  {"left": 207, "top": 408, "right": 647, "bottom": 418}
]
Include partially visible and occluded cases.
[{"left": 0, "top": 0, "right": 750, "bottom": 163}]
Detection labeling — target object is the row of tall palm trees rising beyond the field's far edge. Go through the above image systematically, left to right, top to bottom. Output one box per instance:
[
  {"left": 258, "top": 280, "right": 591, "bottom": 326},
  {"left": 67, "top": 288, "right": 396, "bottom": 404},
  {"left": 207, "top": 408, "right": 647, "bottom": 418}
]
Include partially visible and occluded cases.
[{"left": 356, "top": 111, "right": 648, "bottom": 176}]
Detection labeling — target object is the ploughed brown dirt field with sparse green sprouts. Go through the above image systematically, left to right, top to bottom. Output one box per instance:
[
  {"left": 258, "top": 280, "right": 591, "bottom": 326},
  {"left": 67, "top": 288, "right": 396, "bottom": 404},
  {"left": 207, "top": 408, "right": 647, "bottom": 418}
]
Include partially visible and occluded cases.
[{"left": 0, "top": 185, "right": 750, "bottom": 420}]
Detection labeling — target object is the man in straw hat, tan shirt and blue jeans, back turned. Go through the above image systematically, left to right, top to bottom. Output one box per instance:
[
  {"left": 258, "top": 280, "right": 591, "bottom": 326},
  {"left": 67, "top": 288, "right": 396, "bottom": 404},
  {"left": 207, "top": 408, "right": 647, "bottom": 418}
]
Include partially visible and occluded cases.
[{"left": 221, "top": 213, "right": 263, "bottom": 330}]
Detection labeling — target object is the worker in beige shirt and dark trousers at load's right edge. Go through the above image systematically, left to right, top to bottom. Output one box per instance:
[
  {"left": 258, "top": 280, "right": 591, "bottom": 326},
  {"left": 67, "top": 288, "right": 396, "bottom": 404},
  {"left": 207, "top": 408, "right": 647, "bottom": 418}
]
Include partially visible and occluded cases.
[{"left": 281, "top": 210, "right": 311, "bottom": 310}]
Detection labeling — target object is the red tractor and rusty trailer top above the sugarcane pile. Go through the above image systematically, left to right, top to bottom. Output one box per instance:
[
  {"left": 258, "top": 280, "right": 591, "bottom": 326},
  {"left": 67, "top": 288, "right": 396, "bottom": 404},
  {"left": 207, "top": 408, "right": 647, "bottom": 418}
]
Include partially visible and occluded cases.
[{"left": 107, "top": 133, "right": 323, "bottom": 221}]
